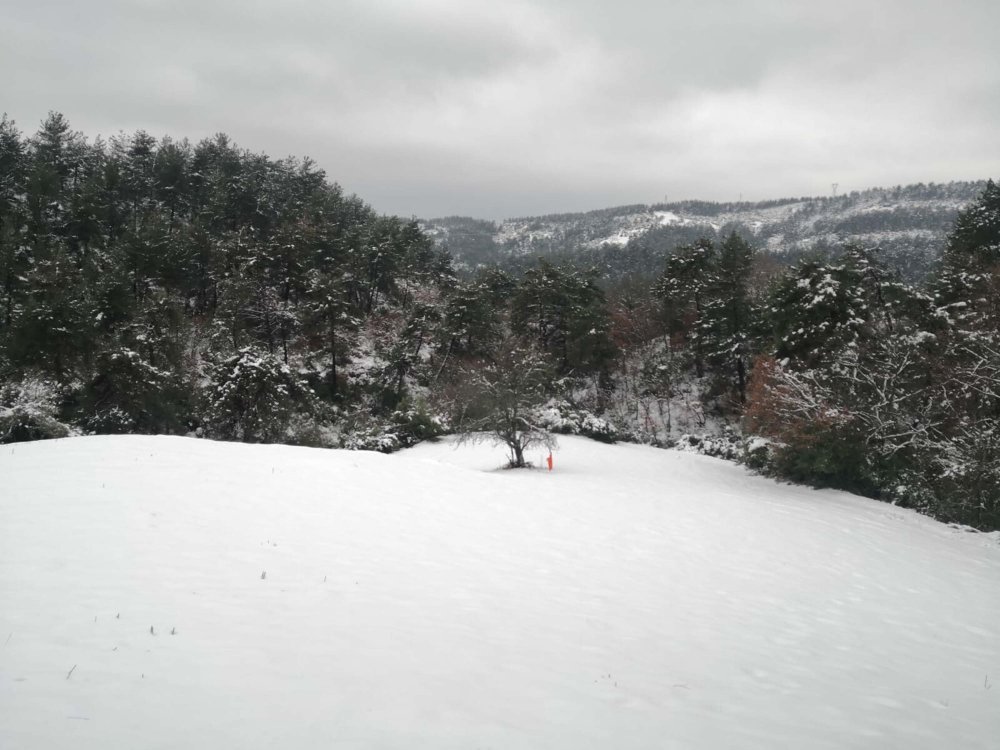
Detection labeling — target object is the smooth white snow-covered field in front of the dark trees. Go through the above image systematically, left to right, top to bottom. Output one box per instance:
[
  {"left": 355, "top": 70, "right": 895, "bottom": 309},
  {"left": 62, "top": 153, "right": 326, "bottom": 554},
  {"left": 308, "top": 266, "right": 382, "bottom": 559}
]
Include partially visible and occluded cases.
[{"left": 0, "top": 437, "right": 1000, "bottom": 750}]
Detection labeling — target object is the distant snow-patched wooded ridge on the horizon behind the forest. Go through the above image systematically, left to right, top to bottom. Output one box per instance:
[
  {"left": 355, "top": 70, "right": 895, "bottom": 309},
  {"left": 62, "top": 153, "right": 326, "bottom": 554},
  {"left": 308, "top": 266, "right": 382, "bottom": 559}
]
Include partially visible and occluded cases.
[{"left": 422, "top": 181, "right": 985, "bottom": 281}]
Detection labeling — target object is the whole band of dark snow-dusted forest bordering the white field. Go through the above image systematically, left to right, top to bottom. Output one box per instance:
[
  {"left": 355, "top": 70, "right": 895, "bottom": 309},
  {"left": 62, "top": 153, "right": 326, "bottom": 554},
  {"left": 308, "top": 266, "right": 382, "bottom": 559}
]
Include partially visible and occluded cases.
[{"left": 0, "top": 113, "right": 1000, "bottom": 529}]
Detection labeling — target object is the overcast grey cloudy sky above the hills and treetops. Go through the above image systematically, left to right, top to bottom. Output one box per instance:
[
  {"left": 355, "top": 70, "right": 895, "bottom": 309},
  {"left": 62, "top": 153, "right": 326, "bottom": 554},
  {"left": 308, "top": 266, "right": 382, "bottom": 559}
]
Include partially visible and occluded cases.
[{"left": 0, "top": 0, "right": 1000, "bottom": 218}]
